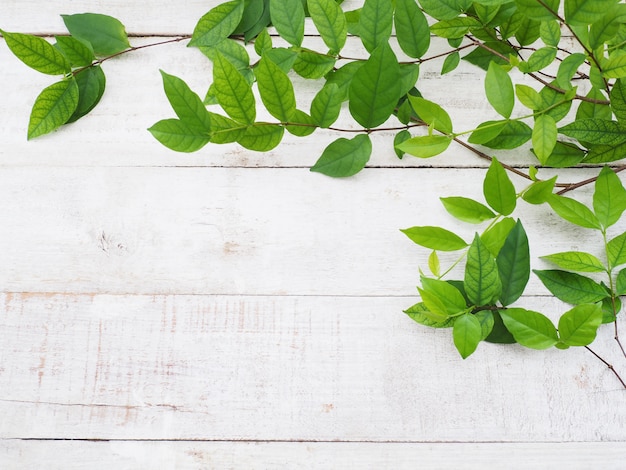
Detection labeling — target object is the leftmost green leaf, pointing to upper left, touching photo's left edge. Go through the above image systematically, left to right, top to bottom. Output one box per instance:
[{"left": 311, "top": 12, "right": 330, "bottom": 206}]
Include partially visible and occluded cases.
[{"left": 0, "top": 30, "right": 70, "bottom": 75}]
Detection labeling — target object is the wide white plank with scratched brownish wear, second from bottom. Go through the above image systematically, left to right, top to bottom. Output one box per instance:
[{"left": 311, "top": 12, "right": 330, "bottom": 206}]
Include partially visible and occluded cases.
[{"left": 0, "top": 294, "right": 626, "bottom": 443}]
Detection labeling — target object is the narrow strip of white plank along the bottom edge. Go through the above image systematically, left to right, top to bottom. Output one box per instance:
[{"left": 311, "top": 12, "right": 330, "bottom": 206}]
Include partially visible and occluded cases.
[{"left": 0, "top": 441, "right": 626, "bottom": 470}]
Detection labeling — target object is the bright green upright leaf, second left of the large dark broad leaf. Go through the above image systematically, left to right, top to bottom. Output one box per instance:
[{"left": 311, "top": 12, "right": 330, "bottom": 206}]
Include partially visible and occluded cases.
[{"left": 254, "top": 57, "right": 296, "bottom": 122}]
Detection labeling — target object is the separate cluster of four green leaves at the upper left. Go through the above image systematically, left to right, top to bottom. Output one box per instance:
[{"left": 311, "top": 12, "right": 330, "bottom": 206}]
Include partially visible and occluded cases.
[{"left": 0, "top": 13, "right": 130, "bottom": 139}]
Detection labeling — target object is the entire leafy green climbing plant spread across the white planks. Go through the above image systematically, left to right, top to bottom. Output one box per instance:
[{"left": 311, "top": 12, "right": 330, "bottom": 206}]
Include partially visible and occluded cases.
[{"left": 1, "top": 0, "right": 626, "bottom": 388}]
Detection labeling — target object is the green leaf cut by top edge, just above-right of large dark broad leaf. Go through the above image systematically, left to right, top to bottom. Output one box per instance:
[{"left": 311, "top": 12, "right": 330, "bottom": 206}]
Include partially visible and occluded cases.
[{"left": 394, "top": 0, "right": 428, "bottom": 59}]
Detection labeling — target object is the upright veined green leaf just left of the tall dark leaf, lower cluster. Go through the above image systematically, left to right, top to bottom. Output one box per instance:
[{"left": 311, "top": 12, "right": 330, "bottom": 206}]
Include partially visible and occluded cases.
[{"left": 464, "top": 234, "right": 502, "bottom": 306}]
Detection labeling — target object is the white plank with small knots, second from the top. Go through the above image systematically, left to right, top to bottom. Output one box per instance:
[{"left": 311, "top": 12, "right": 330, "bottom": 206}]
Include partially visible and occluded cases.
[{"left": 0, "top": 167, "right": 604, "bottom": 296}]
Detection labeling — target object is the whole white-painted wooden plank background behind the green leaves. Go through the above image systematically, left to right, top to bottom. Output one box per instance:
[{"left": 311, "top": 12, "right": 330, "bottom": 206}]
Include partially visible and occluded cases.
[{"left": 0, "top": 0, "right": 626, "bottom": 469}]
